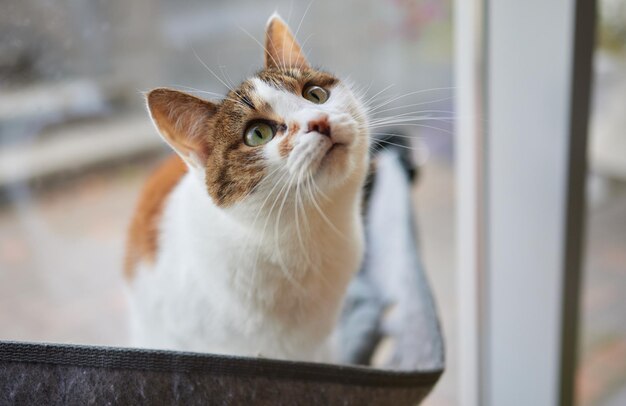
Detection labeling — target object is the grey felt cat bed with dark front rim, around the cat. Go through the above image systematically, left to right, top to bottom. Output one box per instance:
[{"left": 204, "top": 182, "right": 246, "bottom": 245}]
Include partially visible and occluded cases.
[{"left": 0, "top": 146, "right": 444, "bottom": 405}]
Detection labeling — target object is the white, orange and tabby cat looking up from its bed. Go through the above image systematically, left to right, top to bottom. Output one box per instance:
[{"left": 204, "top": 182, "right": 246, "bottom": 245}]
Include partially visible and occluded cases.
[{"left": 125, "top": 14, "right": 369, "bottom": 362}]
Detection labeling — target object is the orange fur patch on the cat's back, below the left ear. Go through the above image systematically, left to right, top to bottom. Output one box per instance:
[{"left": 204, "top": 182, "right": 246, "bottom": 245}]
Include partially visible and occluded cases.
[{"left": 124, "top": 155, "right": 187, "bottom": 279}]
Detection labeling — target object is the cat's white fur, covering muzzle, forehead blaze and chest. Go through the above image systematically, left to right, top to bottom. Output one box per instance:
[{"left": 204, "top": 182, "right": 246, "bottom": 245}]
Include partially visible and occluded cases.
[{"left": 130, "top": 79, "right": 368, "bottom": 361}]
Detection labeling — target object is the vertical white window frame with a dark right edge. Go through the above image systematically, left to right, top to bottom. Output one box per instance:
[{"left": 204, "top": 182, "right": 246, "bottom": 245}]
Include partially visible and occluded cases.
[{"left": 455, "top": 0, "right": 595, "bottom": 406}]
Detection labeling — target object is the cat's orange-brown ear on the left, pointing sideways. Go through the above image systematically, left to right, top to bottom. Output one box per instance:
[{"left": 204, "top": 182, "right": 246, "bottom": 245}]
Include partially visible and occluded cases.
[{"left": 146, "top": 88, "right": 217, "bottom": 169}]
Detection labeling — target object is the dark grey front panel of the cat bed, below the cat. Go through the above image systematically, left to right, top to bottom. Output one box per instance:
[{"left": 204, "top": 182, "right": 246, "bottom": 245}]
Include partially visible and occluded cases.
[{"left": 0, "top": 343, "right": 441, "bottom": 405}]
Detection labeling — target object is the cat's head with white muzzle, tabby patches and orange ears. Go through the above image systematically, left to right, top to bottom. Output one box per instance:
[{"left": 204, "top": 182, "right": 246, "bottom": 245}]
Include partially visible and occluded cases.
[{"left": 147, "top": 15, "right": 369, "bottom": 207}]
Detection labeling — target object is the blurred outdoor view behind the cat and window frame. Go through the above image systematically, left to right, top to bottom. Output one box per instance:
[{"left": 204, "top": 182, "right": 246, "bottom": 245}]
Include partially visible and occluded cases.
[{"left": 0, "top": 0, "right": 626, "bottom": 405}]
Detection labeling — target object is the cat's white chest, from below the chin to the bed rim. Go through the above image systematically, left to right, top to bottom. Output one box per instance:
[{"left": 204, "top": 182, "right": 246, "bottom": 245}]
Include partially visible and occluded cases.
[{"left": 133, "top": 173, "right": 363, "bottom": 357}]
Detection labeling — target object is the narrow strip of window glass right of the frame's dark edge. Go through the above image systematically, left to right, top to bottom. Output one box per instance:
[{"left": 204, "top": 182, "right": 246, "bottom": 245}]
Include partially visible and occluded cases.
[{"left": 577, "top": 0, "right": 626, "bottom": 405}]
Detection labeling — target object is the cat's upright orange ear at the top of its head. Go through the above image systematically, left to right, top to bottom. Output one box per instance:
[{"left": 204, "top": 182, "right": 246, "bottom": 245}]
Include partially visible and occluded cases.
[{"left": 265, "top": 13, "right": 309, "bottom": 69}]
